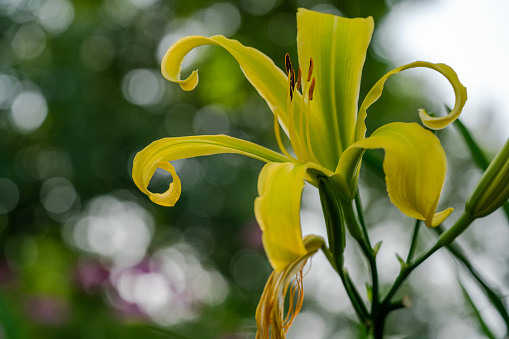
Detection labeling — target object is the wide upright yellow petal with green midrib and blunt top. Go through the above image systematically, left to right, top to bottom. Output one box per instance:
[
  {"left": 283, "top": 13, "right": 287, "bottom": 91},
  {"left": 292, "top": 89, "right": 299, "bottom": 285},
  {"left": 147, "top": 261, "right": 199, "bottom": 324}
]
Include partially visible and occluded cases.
[{"left": 297, "top": 8, "right": 374, "bottom": 170}]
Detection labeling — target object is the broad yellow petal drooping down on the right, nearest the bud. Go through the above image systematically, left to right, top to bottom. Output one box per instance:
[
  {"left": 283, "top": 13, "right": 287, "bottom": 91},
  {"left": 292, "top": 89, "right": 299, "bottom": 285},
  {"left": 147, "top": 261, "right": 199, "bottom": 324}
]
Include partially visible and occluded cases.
[{"left": 337, "top": 122, "right": 453, "bottom": 227}]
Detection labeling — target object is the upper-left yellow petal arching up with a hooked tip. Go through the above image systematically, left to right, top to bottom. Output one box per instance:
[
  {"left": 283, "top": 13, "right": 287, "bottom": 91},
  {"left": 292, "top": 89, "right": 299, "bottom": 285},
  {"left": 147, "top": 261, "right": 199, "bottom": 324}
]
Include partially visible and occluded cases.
[{"left": 161, "top": 35, "right": 300, "bottom": 130}]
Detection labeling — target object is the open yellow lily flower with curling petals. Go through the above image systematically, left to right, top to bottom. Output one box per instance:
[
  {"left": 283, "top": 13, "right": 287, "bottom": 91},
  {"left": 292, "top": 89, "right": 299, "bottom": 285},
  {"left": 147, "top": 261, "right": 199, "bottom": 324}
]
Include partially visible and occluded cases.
[{"left": 133, "top": 9, "right": 466, "bottom": 272}]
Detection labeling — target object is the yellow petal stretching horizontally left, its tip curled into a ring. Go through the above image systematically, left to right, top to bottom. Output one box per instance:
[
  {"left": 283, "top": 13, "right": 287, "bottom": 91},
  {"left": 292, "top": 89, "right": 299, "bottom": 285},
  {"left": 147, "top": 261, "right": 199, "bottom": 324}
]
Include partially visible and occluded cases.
[{"left": 132, "top": 135, "right": 288, "bottom": 206}]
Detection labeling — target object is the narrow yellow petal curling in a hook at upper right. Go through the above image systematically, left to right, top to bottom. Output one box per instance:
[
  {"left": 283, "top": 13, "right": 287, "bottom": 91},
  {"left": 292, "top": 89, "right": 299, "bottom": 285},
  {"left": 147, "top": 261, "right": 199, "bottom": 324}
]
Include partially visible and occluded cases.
[{"left": 356, "top": 61, "right": 467, "bottom": 140}]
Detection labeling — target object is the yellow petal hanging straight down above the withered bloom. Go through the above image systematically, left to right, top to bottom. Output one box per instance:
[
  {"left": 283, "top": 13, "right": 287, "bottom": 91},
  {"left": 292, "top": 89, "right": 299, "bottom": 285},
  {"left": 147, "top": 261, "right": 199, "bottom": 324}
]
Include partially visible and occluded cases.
[{"left": 255, "top": 162, "right": 322, "bottom": 271}]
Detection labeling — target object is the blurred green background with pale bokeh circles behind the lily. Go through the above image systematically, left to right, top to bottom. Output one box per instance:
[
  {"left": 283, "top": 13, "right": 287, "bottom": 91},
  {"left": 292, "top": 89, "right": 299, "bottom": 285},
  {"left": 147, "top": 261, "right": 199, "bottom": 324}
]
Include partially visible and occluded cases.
[{"left": 0, "top": 0, "right": 509, "bottom": 339}]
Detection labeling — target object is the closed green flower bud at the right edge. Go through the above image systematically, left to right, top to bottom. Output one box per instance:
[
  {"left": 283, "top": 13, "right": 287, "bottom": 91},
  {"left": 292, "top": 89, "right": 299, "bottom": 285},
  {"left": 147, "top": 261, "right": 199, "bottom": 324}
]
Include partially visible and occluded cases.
[{"left": 465, "top": 140, "right": 509, "bottom": 218}]
